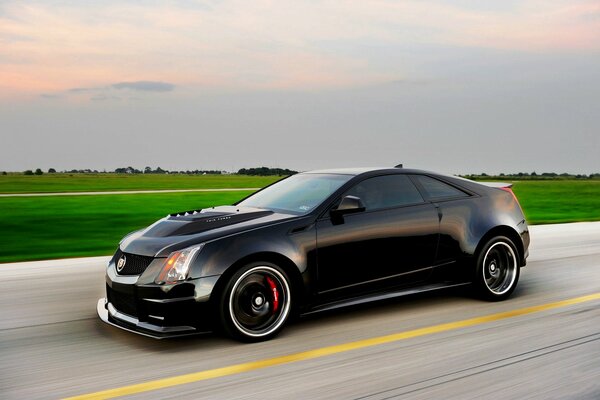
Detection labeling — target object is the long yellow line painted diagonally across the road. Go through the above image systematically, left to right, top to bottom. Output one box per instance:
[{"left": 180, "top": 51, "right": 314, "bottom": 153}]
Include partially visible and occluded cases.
[{"left": 65, "top": 293, "right": 600, "bottom": 400}]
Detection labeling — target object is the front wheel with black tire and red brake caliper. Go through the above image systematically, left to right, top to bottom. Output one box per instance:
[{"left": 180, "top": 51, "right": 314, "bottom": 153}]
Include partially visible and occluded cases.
[{"left": 219, "top": 262, "right": 291, "bottom": 342}]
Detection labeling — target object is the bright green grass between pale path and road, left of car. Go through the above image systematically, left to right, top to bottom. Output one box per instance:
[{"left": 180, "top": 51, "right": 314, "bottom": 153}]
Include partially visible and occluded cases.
[{"left": 0, "top": 191, "right": 252, "bottom": 262}]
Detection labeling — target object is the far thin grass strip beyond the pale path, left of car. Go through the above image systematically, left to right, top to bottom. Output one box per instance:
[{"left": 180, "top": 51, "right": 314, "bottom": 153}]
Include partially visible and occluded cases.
[{"left": 0, "top": 173, "right": 281, "bottom": 193}]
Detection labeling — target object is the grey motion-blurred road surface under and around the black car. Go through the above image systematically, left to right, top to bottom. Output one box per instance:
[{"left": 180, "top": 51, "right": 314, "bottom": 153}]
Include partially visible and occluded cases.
[{"left": 0, "top": 223, "right": 600, "bottom": 400}]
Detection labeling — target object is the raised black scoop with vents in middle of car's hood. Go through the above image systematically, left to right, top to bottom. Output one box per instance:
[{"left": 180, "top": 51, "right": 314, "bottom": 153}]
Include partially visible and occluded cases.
[{"left": 144, "top": 210, "right": 273, "bottom": 237}]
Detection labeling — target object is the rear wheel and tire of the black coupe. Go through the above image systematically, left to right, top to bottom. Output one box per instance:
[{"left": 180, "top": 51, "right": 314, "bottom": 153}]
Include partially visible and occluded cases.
[{"left": 474, "top": 236, "right": 521, "bottom": 301}]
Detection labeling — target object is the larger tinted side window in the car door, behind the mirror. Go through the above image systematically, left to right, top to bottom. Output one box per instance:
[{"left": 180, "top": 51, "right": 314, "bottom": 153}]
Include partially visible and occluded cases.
[{"left": 344, "top": 175, "right": 424, "bottom": 211}]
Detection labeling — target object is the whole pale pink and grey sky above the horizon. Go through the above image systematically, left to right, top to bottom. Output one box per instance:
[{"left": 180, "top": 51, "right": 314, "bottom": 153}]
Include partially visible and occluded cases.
[{"left": 0, "top": 0, "right": 600, "bottom": 174}]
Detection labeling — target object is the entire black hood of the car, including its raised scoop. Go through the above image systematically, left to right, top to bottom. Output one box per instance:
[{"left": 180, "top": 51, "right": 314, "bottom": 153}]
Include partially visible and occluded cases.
[{"left": 119, "top": 206, "right": 297, "bottom": 257}]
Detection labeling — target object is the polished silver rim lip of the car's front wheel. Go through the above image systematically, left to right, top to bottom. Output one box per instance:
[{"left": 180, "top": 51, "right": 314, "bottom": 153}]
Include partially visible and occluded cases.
[{"left": 229, "top": 265, "right": 291, "bottom": 338}]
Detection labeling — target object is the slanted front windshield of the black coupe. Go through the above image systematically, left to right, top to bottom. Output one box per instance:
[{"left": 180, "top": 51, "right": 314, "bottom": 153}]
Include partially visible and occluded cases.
[{"left": 238, "top": 174, "right": 352, "bottom": 214}]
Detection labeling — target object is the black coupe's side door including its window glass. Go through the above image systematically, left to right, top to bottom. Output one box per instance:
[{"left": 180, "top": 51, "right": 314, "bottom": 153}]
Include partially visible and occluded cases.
[{"left": 317, "top": 174, "right": 439, "bottom": 294}]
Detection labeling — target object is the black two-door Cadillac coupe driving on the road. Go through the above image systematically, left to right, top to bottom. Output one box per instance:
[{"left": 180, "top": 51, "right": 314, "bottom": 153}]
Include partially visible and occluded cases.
[{"left": 98, "top": 168, "right": 529, "bottom": 341}]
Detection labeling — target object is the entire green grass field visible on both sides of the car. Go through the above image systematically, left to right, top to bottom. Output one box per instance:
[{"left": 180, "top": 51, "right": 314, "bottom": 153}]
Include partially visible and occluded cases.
[{"left": 0, "top": 176, "right": 600, "bottom": 262}]
